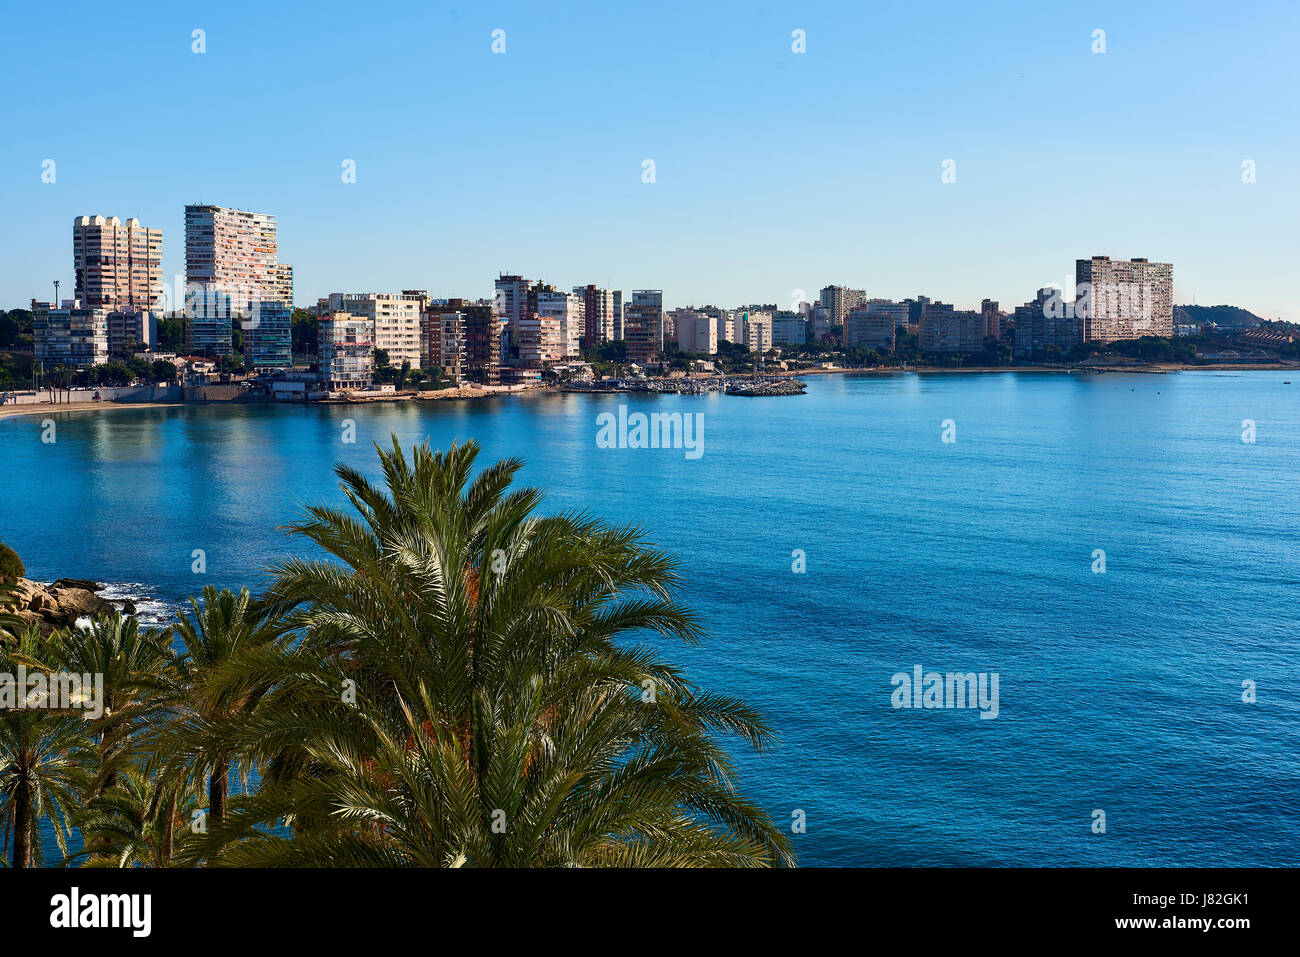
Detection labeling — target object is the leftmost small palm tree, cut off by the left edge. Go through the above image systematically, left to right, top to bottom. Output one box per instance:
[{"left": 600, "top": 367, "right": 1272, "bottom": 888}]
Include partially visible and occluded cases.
[{"left": 0, "top": 628, "right": 94, "bottom": 867}]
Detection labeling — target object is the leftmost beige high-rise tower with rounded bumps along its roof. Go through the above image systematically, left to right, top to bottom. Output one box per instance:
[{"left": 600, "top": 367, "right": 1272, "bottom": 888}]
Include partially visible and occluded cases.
[{"left": 73, "top": 216, "right": 163, "bottom": 312}]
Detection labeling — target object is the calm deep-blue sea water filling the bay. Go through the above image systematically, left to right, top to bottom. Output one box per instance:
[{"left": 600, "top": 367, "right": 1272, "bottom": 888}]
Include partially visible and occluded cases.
[{"left": 0, "top": 372, "right": 1300, "bottom": 865}]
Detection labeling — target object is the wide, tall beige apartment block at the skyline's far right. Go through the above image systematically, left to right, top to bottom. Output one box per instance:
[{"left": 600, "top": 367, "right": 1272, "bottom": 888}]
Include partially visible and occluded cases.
[{"left": 1074, "top": 256, "right": 1174, "bottom": 342}]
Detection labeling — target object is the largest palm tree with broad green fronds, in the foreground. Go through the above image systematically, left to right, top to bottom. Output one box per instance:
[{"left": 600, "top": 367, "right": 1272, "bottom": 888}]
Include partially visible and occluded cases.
[{"left": 192, "top": 438, "right": 792, "bottom": 866}]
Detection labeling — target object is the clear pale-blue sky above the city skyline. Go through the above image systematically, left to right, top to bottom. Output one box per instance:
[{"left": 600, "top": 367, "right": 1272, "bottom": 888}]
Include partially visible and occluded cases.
[{"left": 0, "top": 0, "right": 1300, "bottom": 321}]
